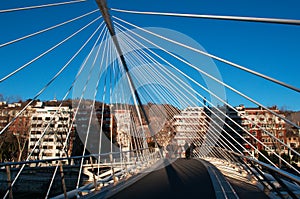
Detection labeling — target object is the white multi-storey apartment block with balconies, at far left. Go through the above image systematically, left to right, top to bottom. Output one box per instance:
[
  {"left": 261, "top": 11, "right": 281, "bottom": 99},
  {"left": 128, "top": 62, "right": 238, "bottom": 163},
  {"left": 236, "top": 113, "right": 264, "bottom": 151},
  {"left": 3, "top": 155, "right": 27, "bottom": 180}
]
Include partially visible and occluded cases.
[{"left": 28, "top": 103, "right": 72, "bottom": 164}]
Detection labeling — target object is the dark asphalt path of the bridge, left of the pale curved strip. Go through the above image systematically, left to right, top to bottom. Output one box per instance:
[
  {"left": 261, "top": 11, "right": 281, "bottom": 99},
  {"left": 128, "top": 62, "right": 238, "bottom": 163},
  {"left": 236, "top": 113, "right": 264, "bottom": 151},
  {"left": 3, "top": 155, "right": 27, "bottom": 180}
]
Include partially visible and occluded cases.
[{"left": 110, "top": 159, "right": 216, "bottom": 199}]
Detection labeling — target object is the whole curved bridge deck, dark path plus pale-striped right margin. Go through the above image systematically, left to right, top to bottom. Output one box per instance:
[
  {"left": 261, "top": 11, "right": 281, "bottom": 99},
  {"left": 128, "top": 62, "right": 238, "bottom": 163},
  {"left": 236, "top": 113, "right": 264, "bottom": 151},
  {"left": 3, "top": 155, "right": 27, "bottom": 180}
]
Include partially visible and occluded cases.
[{"left": 84, "top": 159, "right": 267, "bottom": 199}]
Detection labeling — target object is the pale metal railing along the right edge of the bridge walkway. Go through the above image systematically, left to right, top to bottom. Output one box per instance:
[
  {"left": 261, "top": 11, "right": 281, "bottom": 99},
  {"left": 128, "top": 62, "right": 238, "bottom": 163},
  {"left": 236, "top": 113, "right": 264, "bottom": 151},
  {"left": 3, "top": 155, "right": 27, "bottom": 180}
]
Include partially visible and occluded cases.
[{"left": 201, "top": 147, "right": 300, "bottom": 199}]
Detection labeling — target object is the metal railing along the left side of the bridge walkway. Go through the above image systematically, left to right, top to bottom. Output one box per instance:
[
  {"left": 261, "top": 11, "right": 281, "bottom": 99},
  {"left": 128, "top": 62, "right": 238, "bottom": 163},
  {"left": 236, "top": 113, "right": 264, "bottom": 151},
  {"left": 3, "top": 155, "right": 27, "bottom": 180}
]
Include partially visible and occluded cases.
[{"left": 0, "top": 148, "right": 160, "bottom": 198}]
